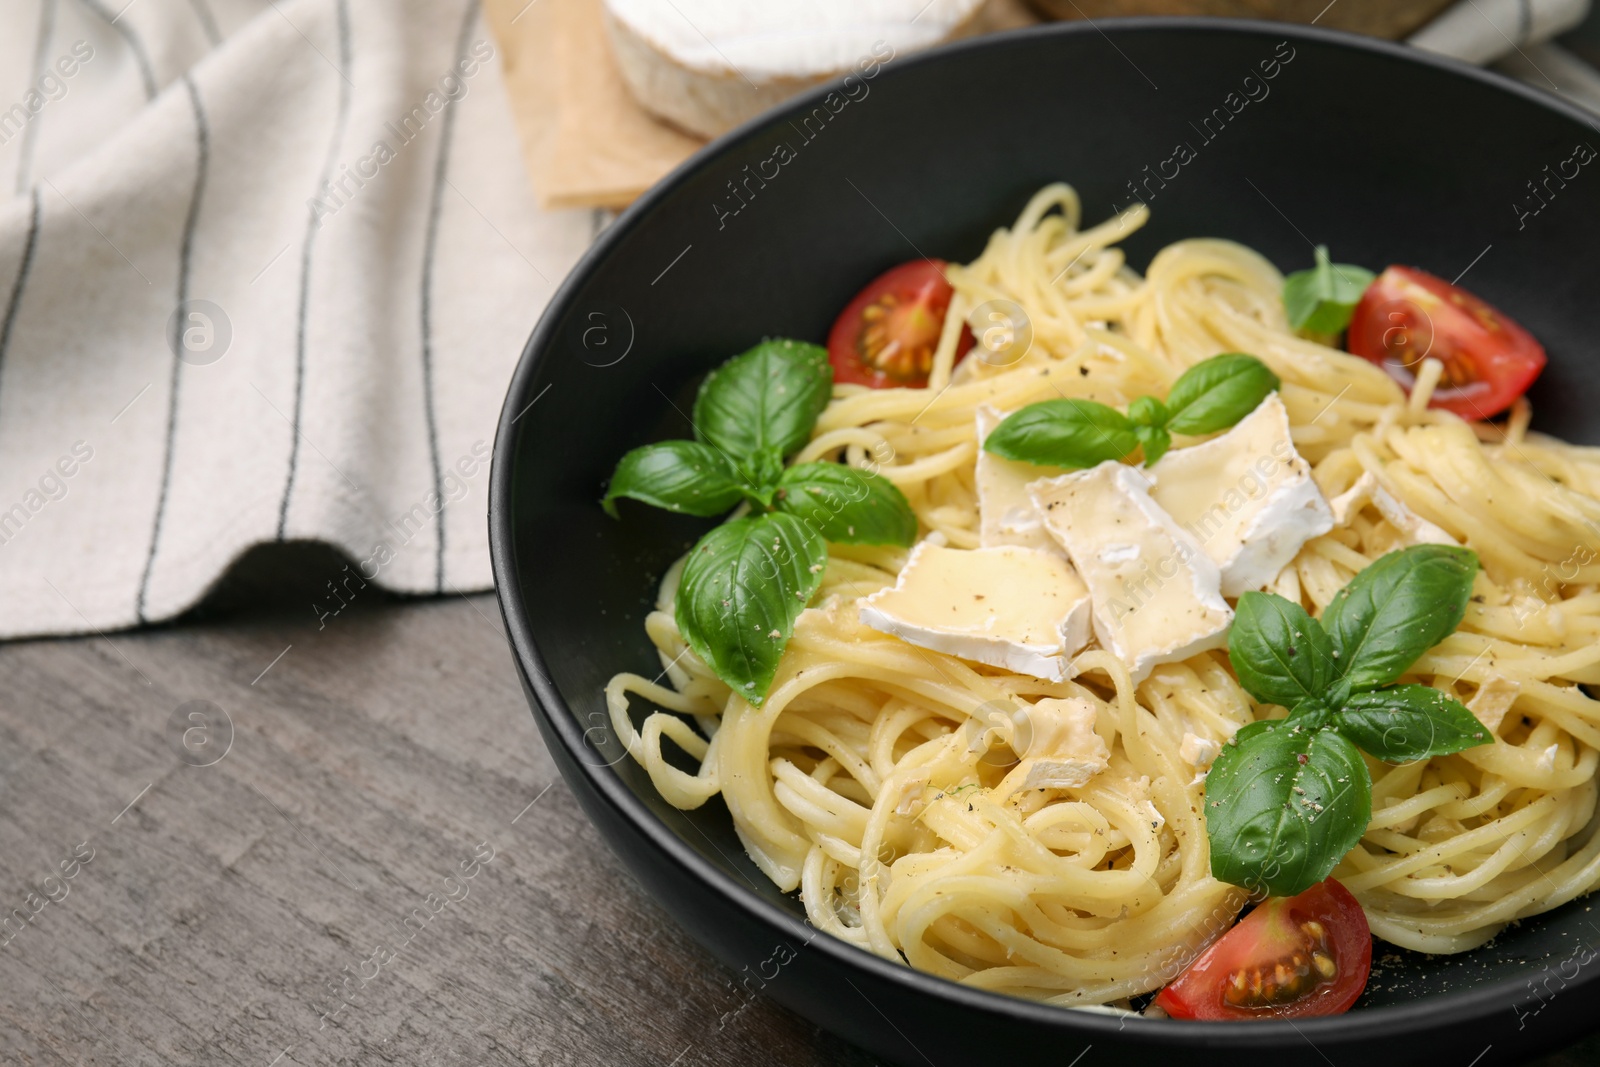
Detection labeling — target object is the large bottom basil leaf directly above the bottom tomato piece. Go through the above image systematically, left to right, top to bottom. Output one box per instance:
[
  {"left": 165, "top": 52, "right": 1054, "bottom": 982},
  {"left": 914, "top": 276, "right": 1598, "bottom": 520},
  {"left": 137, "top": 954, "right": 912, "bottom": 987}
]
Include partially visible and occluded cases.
[{"left": 1205, "top": 720, "right": 1373, "bottom": 896}]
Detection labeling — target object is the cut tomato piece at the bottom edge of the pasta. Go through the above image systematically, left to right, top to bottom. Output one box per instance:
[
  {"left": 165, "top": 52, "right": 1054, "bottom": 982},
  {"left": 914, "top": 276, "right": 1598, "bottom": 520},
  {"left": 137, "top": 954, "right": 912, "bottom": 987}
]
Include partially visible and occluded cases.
[{"left": 1155, "top": 878, "right": 1373, "bottom": 1019}]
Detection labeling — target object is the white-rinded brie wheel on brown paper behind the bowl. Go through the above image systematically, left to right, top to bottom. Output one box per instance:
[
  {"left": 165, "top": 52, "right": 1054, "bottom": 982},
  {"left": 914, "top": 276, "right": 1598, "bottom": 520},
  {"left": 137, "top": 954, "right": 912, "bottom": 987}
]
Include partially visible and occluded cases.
[{"left": 605, "top": 0, "right": 986, "bottom": 137}]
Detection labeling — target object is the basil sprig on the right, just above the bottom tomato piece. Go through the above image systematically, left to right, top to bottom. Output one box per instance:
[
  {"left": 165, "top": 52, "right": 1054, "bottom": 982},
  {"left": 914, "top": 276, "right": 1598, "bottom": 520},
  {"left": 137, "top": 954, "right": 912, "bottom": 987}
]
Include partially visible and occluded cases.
[{"left": 1205, "top": 544, "right": 1494, "bottom": 896}]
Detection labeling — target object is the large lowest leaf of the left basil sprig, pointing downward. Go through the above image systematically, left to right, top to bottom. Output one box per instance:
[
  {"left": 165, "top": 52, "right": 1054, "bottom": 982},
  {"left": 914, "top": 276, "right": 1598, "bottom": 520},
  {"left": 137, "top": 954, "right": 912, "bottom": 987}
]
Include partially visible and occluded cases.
[{"left": 675, "top": 512, "right": 827, "bottom": 705}]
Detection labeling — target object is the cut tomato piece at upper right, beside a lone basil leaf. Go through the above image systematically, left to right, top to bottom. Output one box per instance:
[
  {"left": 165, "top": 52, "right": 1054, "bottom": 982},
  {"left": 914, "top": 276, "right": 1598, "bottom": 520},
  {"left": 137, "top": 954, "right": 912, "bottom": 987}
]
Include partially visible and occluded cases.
[{"left": 1349, "top": 267, "right": 1544, "bottom": 419}]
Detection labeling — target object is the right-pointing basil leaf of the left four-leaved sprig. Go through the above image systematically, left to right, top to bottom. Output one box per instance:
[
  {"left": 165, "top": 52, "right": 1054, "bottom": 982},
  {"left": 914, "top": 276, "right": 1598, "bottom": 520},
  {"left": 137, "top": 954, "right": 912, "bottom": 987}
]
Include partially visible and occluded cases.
[{"left": 776, "top": 462, "right": 917, "bottom": 545}]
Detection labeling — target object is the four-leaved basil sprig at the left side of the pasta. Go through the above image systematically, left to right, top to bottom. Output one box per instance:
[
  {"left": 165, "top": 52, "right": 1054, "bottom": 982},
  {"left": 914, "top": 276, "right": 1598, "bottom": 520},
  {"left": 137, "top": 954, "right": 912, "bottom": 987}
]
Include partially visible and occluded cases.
[{"left": 602, "top": 339, "right": 917, "bottom": 705}]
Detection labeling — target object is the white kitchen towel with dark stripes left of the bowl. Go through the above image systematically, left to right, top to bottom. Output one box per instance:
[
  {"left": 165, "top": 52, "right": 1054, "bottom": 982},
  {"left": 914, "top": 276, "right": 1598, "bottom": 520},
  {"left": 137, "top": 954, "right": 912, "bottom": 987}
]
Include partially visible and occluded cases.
[{"left": 0, "top": 0, "right": 590, "bottom": 637}]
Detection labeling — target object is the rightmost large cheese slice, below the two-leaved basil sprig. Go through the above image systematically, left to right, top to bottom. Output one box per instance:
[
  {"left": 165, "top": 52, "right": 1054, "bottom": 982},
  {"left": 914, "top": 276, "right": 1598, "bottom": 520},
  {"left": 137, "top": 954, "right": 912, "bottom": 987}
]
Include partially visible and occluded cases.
[{"left": 1150, "top": 394, "right": 1333, "bottom": 597}]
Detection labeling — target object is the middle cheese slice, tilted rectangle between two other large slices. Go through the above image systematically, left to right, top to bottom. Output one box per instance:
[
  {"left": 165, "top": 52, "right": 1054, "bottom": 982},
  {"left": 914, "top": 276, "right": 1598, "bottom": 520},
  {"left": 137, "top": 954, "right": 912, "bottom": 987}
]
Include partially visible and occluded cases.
[{"left": 1029, "top": 461, "right": 1234, "bottom": 681}]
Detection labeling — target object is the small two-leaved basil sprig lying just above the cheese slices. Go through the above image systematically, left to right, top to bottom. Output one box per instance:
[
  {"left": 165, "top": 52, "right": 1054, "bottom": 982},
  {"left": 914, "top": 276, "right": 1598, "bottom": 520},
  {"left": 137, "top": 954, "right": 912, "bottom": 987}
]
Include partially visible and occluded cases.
[{"left": 984, "top": 352, "right": 1278, "bottom": 467}]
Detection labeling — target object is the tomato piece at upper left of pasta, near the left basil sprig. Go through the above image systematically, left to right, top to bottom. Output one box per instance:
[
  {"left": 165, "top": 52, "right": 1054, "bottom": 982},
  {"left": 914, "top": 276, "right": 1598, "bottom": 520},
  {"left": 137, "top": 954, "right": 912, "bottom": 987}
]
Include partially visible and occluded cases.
[{"left": 827, "top": 259, "right": 973, "bottom": 389}]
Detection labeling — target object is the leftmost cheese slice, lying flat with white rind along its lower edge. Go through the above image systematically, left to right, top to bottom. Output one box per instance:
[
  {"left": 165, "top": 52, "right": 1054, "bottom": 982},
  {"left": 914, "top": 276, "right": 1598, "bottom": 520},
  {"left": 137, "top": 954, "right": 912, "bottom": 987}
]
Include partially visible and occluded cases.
[{"left": 859, "top": 541, "right": 1090, "bottom": 681}]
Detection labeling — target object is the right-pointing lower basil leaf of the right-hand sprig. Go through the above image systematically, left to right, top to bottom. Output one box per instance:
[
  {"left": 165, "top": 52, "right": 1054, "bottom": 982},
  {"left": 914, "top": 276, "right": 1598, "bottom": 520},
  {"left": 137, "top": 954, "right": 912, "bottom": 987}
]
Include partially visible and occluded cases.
[{"left": 1333, "top": 685, "right": 1494, "bottom": 763}]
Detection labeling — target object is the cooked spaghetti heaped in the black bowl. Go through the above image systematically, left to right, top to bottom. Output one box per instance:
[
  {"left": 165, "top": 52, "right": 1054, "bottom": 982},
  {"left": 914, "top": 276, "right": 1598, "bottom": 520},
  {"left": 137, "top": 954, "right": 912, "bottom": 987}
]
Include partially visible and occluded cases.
[{"left": 606, "top": 184, "right": 1600, "bottom": 1005}]
